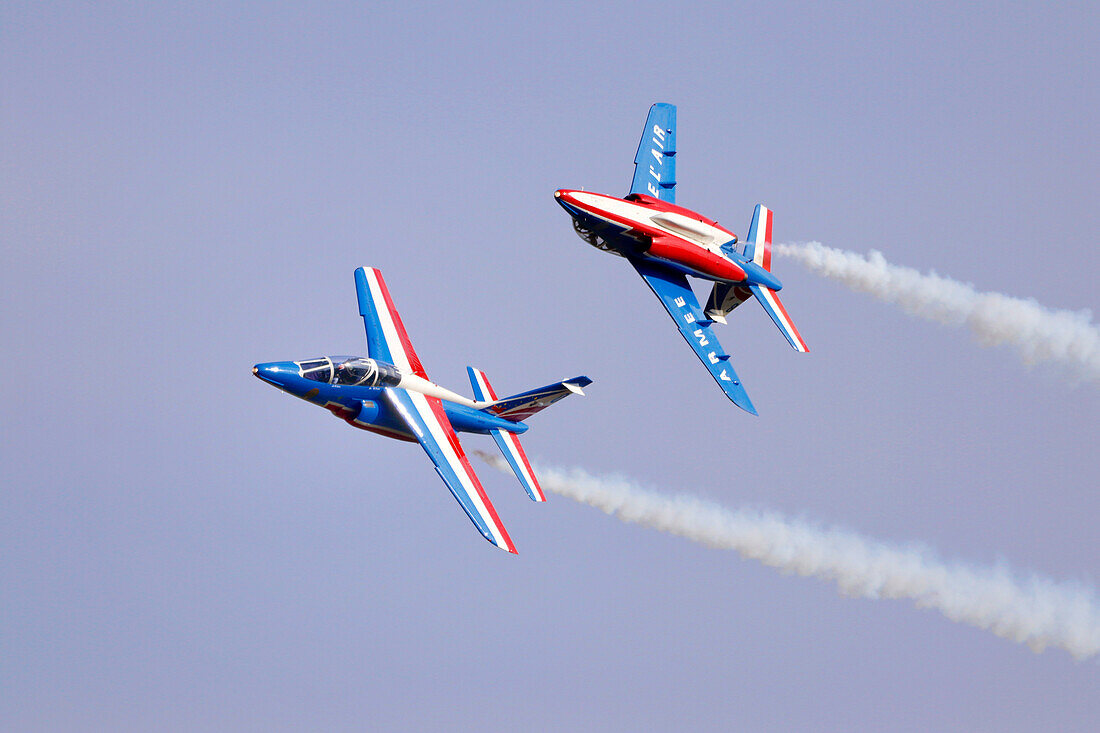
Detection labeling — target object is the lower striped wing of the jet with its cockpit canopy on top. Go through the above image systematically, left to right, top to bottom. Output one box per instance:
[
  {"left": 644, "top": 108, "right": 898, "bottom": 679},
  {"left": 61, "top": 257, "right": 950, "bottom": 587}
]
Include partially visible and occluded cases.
[{"left": 383, "top": 387, "right": 516, "bottom": 554}]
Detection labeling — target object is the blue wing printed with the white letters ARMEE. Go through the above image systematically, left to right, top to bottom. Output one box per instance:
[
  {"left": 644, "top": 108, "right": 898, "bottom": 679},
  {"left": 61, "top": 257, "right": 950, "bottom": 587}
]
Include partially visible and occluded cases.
[{"left": 630, "top": 260, "right": 757, "bottom": 415}]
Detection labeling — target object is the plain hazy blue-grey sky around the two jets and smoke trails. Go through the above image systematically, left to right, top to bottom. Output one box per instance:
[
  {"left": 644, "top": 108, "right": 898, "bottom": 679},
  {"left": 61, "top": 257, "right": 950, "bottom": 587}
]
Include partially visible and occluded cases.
[{"left": 0, "top": 2, "right": 1100, "bottom": 731}]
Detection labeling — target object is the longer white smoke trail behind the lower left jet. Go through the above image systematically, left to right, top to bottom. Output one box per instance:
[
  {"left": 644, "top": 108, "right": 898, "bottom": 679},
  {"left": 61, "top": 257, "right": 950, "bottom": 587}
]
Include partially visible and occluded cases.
[{"left": 477, "top": 451, "right": 1100, "bottom": 659}]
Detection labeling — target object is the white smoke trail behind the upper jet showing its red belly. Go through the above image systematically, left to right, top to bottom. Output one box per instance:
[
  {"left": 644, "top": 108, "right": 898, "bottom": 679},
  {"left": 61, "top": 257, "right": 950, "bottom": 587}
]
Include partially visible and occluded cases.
[{"left": 776, "top": 242, "right": 1100, "bottom": 382}]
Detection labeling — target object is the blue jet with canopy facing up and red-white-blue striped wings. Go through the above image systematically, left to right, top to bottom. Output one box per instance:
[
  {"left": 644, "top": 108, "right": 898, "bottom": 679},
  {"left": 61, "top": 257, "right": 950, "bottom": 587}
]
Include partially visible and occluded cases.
[{"left": 252, "top": 267, "right": 592, "bottom": 554}]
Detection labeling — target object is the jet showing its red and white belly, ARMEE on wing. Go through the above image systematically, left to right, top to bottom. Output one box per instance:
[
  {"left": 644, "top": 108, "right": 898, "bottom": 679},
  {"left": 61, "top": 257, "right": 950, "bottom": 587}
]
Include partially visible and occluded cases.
[{"left": 554, "top": 103, "right": 809, "bottom": 415}]
